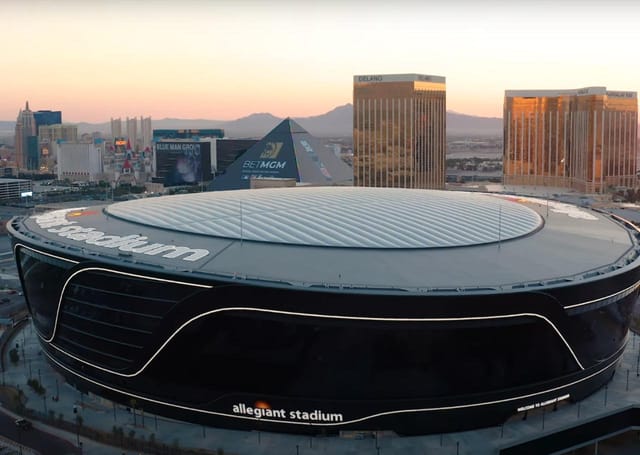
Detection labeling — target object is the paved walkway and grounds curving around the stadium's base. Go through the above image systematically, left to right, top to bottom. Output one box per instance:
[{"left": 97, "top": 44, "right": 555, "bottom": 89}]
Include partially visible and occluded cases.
[{"left": 2, "top": 322, "right": 640, "bottom": 455}]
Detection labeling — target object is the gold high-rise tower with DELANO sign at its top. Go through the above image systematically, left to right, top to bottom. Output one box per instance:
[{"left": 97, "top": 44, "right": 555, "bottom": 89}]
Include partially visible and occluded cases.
[{"left": 353, "top": 74, "right": 446, "bottom": 189}]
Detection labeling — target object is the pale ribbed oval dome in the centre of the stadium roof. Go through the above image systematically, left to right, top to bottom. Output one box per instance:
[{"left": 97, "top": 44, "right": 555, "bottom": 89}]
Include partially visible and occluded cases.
[{"left": 107, "top": 187, "right": 542, "bottom": 248}]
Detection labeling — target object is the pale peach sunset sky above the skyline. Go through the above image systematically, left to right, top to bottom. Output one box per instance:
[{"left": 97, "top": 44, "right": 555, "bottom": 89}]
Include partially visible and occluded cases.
[{"left": 0, "top": 0, "right": 640, "bottom": 122}]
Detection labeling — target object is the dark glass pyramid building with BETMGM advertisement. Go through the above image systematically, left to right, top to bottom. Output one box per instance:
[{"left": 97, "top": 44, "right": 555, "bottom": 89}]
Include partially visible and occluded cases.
[{"left": 212, "top": 118, "right": 353, "bottom": 190}]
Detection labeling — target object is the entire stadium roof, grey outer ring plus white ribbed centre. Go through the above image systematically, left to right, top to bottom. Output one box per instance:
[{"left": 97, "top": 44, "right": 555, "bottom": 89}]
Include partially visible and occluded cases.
[{"left": 10, "top": 187, "right": 640, "bottom": 293}]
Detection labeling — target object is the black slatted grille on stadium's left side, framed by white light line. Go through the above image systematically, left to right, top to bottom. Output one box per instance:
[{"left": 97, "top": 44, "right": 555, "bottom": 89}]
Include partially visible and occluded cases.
[{"left": 54, "top": 271, "right": 197, "bottom": 371}]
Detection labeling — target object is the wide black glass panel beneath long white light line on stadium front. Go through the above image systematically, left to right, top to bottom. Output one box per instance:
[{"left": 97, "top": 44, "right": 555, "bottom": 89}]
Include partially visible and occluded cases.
[{"left": 144, "top": 312, "right": 577, "bottom": 400}]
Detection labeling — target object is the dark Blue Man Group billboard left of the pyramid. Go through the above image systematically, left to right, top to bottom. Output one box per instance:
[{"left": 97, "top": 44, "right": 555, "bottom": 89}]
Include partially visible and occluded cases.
[{"left": 155, "top": 141, "right": 212, "bottom": 186}]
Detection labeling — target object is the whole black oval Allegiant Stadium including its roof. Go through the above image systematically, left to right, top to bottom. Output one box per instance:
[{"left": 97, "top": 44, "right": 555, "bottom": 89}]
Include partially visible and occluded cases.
[{"left": 9, "top": 187, "right": 640, "bottom": 434}]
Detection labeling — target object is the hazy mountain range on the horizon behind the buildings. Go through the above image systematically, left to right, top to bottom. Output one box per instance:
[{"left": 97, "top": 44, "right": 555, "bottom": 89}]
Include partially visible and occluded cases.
[{"left": 0, "top": 104, "right": 502, "bottom": 138}]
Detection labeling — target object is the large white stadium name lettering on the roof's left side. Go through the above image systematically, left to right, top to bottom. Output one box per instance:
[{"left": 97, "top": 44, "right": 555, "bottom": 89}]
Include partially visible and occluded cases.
[{"left": 31, "top": 207, "right": 209, "bottom": 262}]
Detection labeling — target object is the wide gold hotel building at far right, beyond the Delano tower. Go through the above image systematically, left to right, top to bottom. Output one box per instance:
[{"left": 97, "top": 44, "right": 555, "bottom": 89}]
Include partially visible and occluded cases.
[{"left": 503, "top": 87, "right": 638, "bottom": 193}]
